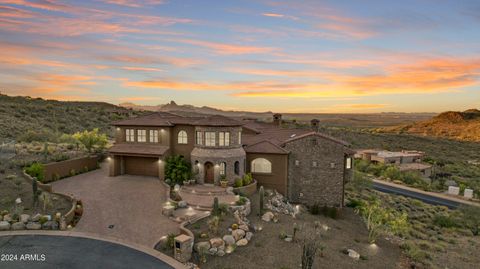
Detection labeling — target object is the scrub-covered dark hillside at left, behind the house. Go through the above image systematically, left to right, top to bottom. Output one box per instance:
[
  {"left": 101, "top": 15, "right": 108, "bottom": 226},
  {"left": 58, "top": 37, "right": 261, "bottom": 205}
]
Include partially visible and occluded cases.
[{"left": 0, "top": 94, "right": 145, "bottom": 142}]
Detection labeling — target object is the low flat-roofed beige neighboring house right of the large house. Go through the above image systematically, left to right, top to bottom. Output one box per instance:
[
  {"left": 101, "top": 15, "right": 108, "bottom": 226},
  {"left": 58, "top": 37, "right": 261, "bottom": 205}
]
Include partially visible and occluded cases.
[{"left": 355, "top": 149, "right": 432, "bottom": 177}]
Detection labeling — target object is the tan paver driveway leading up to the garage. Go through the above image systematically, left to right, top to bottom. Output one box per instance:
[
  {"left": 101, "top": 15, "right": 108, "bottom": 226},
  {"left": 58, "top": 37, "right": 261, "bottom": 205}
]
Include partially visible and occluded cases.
[{"left": 53, "top": 165, "right": 178, "bottom": 247}]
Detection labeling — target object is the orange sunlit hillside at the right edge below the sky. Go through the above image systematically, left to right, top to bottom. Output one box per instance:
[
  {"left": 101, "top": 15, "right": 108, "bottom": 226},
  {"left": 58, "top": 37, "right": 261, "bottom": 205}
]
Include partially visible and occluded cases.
[{"left": 382, "top": 109, "right": 480, "bottom": 142}]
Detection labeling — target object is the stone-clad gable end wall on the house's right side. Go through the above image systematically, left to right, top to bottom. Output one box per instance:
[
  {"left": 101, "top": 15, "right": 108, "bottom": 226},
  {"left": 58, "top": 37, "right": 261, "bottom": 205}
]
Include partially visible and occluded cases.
[{"left": 285, "top": 136, "right": 350, "bottom": 207}]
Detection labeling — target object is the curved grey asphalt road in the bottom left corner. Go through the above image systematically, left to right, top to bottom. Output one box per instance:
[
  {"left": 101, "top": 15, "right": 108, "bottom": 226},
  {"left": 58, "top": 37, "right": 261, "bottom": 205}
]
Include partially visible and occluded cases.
[{"left": 0, "top": 235, "right": 173, "bottom": 269}]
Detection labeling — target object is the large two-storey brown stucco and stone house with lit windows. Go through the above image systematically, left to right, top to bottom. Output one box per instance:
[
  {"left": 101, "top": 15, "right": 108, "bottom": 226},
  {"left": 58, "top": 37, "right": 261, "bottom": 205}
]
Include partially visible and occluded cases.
[{"left": 110, "top": 112, "right": 353, "bottom": 207}]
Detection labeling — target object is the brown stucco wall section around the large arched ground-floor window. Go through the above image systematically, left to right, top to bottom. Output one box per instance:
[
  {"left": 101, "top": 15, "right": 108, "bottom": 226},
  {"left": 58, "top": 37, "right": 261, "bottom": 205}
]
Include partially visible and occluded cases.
[{"left": 246, "top": 153, "right": 288, "bottom": 195}]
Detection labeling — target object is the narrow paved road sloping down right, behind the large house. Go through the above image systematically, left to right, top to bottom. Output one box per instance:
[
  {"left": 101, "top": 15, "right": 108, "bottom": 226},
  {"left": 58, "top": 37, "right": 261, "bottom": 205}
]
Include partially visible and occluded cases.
[{"left": 373, "top": 182, "right": 460, "bottom": 209}]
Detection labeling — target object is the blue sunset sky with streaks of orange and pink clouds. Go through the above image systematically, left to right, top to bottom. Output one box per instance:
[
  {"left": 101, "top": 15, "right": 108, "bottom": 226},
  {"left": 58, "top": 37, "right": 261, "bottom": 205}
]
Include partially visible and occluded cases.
[{"left": 0, "top": 0, "right": 480, "bottom": 113}]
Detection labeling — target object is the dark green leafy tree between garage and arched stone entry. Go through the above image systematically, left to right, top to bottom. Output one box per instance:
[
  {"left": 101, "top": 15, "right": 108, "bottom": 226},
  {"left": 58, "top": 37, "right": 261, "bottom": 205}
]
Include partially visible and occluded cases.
[{"left": 165, "top": 155, "right": 192, "bottom": 186}]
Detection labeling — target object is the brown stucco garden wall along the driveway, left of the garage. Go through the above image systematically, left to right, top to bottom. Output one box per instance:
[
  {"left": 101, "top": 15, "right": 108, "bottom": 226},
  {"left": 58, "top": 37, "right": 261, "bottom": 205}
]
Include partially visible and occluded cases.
[{"left": 44, "top": 156, "right": 99, "bottom": 182}]
